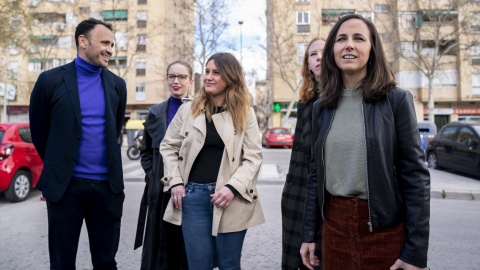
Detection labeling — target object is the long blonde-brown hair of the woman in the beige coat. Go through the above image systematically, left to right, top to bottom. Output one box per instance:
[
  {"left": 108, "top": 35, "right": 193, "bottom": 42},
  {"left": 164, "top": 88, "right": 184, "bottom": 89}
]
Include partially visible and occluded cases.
[{"left": 192, "top": 53, "right": 252, "bottom": 132}]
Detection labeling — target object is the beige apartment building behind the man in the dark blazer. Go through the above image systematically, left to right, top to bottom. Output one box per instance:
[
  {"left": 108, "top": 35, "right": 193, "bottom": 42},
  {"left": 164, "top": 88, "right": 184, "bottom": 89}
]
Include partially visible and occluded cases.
[{"left": 0, "top": 0, "right": 195, "bottom": 122}]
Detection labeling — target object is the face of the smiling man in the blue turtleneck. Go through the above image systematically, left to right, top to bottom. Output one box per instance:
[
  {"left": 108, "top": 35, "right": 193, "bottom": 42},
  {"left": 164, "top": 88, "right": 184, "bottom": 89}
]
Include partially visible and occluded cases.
[{"left": 79, "top": 24, "right": 113, "bottom": 67}]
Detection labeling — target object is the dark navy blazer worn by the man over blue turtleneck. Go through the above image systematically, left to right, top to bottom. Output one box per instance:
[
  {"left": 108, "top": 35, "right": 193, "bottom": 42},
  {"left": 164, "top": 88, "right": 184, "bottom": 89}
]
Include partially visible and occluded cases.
[{"left": 30, "top": 61, "right": 127, "bottom": 202}]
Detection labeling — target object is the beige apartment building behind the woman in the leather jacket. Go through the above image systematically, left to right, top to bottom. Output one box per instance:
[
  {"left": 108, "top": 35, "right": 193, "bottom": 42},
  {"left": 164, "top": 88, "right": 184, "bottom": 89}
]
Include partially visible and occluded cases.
[{"left": 266, "top": 0, "right": 480, "bottom": 127}]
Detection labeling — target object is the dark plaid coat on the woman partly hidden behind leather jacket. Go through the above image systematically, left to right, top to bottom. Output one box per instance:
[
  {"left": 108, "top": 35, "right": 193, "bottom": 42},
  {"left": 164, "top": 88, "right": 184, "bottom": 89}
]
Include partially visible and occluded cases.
[{"left": 281, "top": 100, "right": 321, "bottom": 270}]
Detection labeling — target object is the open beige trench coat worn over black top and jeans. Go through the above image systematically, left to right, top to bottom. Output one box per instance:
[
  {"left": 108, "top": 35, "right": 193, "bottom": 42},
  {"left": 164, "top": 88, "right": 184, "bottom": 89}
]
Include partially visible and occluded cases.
[{"left": 160, "top": 103, "right": 265, "bottom": 236}]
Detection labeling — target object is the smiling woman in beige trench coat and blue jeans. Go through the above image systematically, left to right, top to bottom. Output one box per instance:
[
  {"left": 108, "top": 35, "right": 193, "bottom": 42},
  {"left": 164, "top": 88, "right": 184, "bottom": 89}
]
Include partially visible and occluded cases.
[{"left": 160, "top": 53, "right": 264, "bottom": 270}]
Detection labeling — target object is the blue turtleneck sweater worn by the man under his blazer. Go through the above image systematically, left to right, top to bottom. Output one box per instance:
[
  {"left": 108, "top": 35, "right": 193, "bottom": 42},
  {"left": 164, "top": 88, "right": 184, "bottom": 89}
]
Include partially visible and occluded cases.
[{"left": 73, "top": 55, "right": 108, "bottom": 180}]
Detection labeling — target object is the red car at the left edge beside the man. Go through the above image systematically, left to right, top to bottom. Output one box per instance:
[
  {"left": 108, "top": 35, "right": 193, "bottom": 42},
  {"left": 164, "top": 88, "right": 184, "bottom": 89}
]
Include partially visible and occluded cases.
[{"left": 0, "top": 123, "right": 43, "bottom": 202}]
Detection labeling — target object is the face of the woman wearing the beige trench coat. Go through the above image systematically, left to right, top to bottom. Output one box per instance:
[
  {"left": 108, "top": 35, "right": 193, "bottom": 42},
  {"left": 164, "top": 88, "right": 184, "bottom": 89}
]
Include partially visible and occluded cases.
[{"left": 203, "top": 59, "right": 227, "bottom": 106}]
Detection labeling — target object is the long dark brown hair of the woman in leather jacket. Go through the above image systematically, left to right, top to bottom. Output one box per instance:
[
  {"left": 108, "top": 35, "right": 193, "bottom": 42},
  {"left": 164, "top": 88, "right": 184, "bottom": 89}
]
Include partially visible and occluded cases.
[{"left": 320, "top": 14, "right": 397, "bottom": 108}]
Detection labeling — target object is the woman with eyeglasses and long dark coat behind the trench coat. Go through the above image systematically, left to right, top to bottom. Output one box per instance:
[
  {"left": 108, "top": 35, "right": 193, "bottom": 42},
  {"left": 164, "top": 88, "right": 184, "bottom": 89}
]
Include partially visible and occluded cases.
[{"left": 135, "top": 61, "right": 193, "bottom": 270}]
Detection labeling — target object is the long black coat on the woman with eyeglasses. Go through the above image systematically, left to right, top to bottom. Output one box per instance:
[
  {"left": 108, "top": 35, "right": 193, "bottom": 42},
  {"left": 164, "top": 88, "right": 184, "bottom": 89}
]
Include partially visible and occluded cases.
[{"left": 134, "top": 100, "right": 188, "bottom": 270}]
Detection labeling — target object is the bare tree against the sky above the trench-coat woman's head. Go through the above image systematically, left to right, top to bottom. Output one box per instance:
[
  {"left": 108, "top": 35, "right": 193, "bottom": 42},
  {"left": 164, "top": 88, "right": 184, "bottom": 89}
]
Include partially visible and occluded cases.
[{"left": 195, "top": 0, "right": 233, "bottom": 75}]
